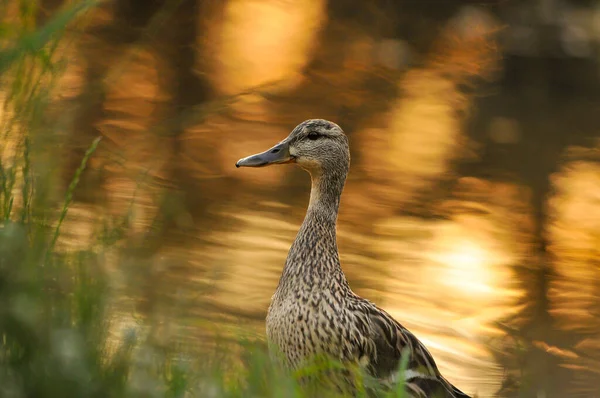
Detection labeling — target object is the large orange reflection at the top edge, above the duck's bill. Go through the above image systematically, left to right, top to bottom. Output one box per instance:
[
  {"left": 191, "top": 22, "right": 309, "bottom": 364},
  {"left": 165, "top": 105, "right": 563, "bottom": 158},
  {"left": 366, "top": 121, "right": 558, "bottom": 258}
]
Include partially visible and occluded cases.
[{"left": 204, "top": 0, "right": 326, "bottom": 94}]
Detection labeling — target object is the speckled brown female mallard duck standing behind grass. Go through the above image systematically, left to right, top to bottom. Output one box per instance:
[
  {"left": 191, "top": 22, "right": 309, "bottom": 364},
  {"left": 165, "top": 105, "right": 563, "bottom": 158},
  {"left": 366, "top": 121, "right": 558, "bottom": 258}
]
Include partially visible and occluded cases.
[{"left": 236, "top": 119, "right": 468, "bottom": 398}]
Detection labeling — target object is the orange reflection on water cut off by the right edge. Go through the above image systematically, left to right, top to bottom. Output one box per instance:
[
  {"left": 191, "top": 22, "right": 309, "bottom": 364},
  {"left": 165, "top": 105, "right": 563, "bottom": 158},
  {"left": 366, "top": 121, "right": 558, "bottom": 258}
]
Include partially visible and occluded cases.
[{"left": 548, "top": 155, "right": 600, "bottom": 330}]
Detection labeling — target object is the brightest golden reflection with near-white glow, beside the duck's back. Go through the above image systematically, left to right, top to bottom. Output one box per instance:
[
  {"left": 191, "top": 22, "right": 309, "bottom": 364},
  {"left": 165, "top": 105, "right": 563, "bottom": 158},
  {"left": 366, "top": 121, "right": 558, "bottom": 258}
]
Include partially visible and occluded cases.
[{"left": 365, "top": 208, "right": 519, "bottom": 396}]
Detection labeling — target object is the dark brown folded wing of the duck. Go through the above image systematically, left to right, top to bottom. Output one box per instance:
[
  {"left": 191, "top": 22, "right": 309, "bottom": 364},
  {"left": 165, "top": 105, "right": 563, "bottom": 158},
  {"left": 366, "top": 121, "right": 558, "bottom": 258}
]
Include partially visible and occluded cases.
[{"left": 354, "top": 299, "right": 470, "bottom": 398}]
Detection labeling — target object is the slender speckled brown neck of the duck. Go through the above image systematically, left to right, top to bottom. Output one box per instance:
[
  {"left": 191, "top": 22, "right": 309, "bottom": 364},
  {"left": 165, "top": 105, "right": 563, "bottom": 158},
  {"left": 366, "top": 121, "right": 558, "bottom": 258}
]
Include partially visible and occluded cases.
[{"left": 280, "top": 167, "right": 349, "bottom": 290}]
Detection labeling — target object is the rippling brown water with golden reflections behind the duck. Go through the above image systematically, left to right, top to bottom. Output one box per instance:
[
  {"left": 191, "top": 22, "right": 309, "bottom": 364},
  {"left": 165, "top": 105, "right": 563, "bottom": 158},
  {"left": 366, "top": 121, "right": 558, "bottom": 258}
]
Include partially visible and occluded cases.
[{"left": 21, "top": 0, "right": 600, "bottom": 397}]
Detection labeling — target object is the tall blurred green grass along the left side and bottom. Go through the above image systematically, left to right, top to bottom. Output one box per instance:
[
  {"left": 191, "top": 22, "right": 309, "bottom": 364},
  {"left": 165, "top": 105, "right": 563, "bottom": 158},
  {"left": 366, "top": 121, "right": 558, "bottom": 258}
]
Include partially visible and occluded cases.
[{"left": 0, "top": 0, "right": 403, "bottom": 398}]
